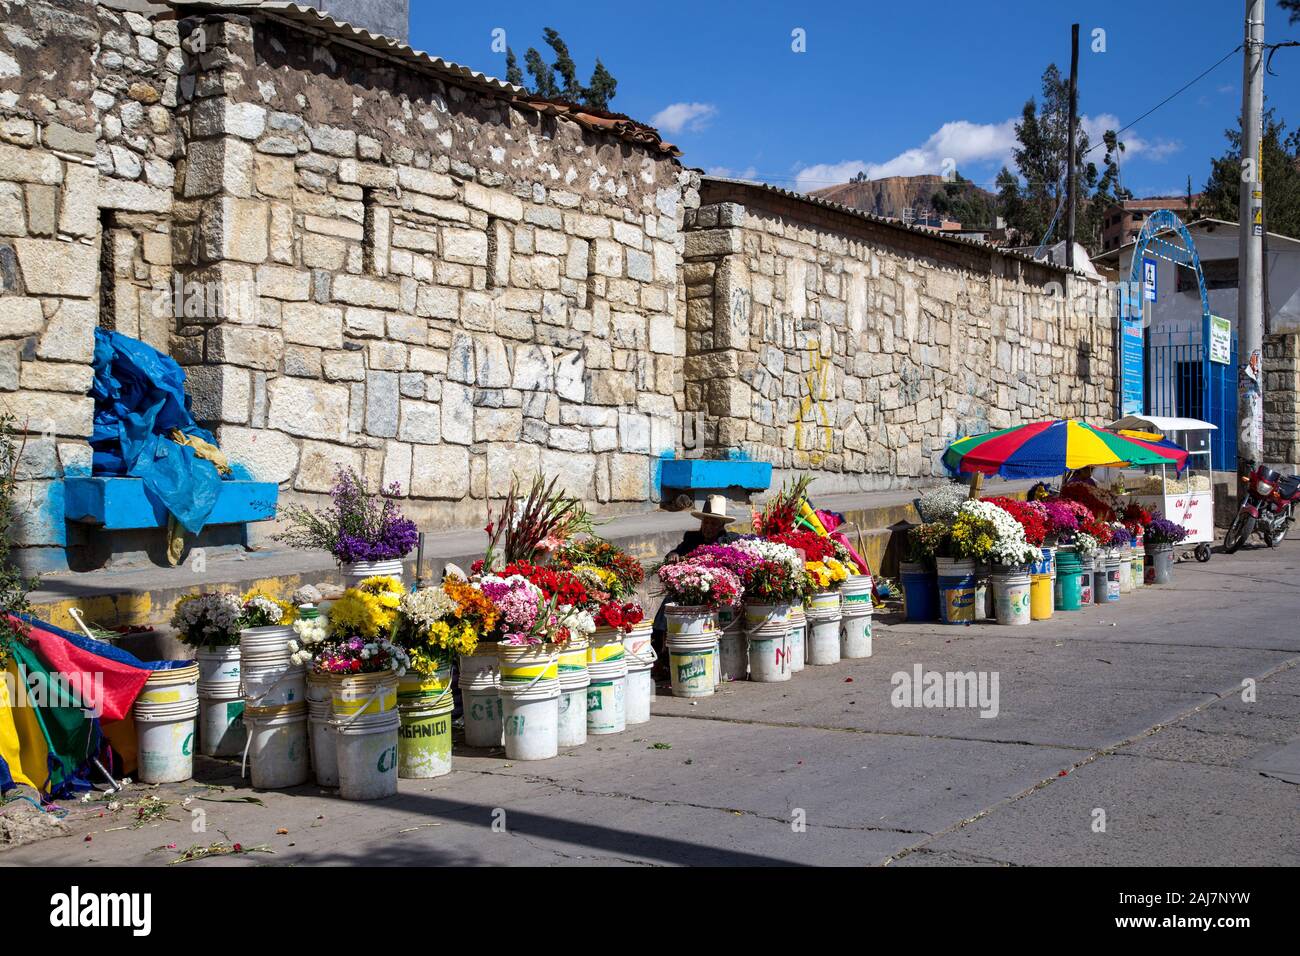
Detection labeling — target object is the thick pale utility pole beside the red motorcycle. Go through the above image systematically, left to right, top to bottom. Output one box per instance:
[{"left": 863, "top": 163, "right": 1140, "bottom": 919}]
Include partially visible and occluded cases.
[{"left": 1236, "top": 0, "right": 1264, "bottom": 476}]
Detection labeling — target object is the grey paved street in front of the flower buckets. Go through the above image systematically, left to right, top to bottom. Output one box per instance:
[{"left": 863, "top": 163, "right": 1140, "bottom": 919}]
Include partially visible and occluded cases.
[{"left": 0, "top": 541, "right": 1300, "bottom": 866}]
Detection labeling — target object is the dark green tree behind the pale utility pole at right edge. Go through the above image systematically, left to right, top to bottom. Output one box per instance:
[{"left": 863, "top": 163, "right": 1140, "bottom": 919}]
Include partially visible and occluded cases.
[{"left": 1199, "top": 104, "right": 1300, "bottom": 238}]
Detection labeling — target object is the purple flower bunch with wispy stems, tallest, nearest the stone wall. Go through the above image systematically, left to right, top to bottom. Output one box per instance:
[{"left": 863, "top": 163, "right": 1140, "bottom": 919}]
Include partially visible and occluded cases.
[{"left": 276, "top": 468, "right": 420, "bottom": 564}]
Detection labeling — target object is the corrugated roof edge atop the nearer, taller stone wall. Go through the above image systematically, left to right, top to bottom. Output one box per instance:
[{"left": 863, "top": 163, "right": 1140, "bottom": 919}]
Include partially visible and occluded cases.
[{"left": 165, "top": 0, "right": 681, "bottom": 156}]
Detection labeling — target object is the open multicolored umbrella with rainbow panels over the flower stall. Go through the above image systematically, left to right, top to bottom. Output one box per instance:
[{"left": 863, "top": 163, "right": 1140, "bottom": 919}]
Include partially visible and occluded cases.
[{"left": 944, "top": 419, "right": 1187, "bottom": 479}]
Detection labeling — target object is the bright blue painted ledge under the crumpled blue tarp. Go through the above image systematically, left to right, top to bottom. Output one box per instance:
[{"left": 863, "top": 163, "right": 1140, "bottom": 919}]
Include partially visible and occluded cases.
[{"left": 64, "top": 477, "right": 280, "bottom": 531}]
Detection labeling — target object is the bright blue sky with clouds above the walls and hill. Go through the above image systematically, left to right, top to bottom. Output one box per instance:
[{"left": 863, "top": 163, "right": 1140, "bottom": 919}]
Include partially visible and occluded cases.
[{"left": 411, "top": 0, "right": 1300, "bottom": 196}]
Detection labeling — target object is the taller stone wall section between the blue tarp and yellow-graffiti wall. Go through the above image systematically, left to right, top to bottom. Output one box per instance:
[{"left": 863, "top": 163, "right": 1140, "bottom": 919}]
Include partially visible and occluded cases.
[{"left": 172, "top": 16, "right": 689, "bottom": 538}]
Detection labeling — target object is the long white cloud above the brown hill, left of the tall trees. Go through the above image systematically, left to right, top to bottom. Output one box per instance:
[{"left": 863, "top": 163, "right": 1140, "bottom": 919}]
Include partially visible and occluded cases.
[{"left": 796, "top": 120, "right": 1015, "bottom": 193}]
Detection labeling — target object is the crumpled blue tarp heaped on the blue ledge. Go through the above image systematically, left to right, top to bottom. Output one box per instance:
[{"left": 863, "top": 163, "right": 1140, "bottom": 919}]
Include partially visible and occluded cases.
[{"left": 90, "top": 329, "right": 221, "bottom": 533}]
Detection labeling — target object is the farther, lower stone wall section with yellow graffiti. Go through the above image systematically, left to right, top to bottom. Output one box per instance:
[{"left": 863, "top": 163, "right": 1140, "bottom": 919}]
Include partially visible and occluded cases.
[{"left": 684, "top": 178, "right": 1115, "bottom": 492}]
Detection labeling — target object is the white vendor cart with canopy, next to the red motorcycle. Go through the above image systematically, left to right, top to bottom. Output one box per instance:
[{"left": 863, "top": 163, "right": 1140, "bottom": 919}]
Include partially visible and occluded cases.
[{"left": 1108, "top": 415, "right": 1218, "bottom": 562}]
